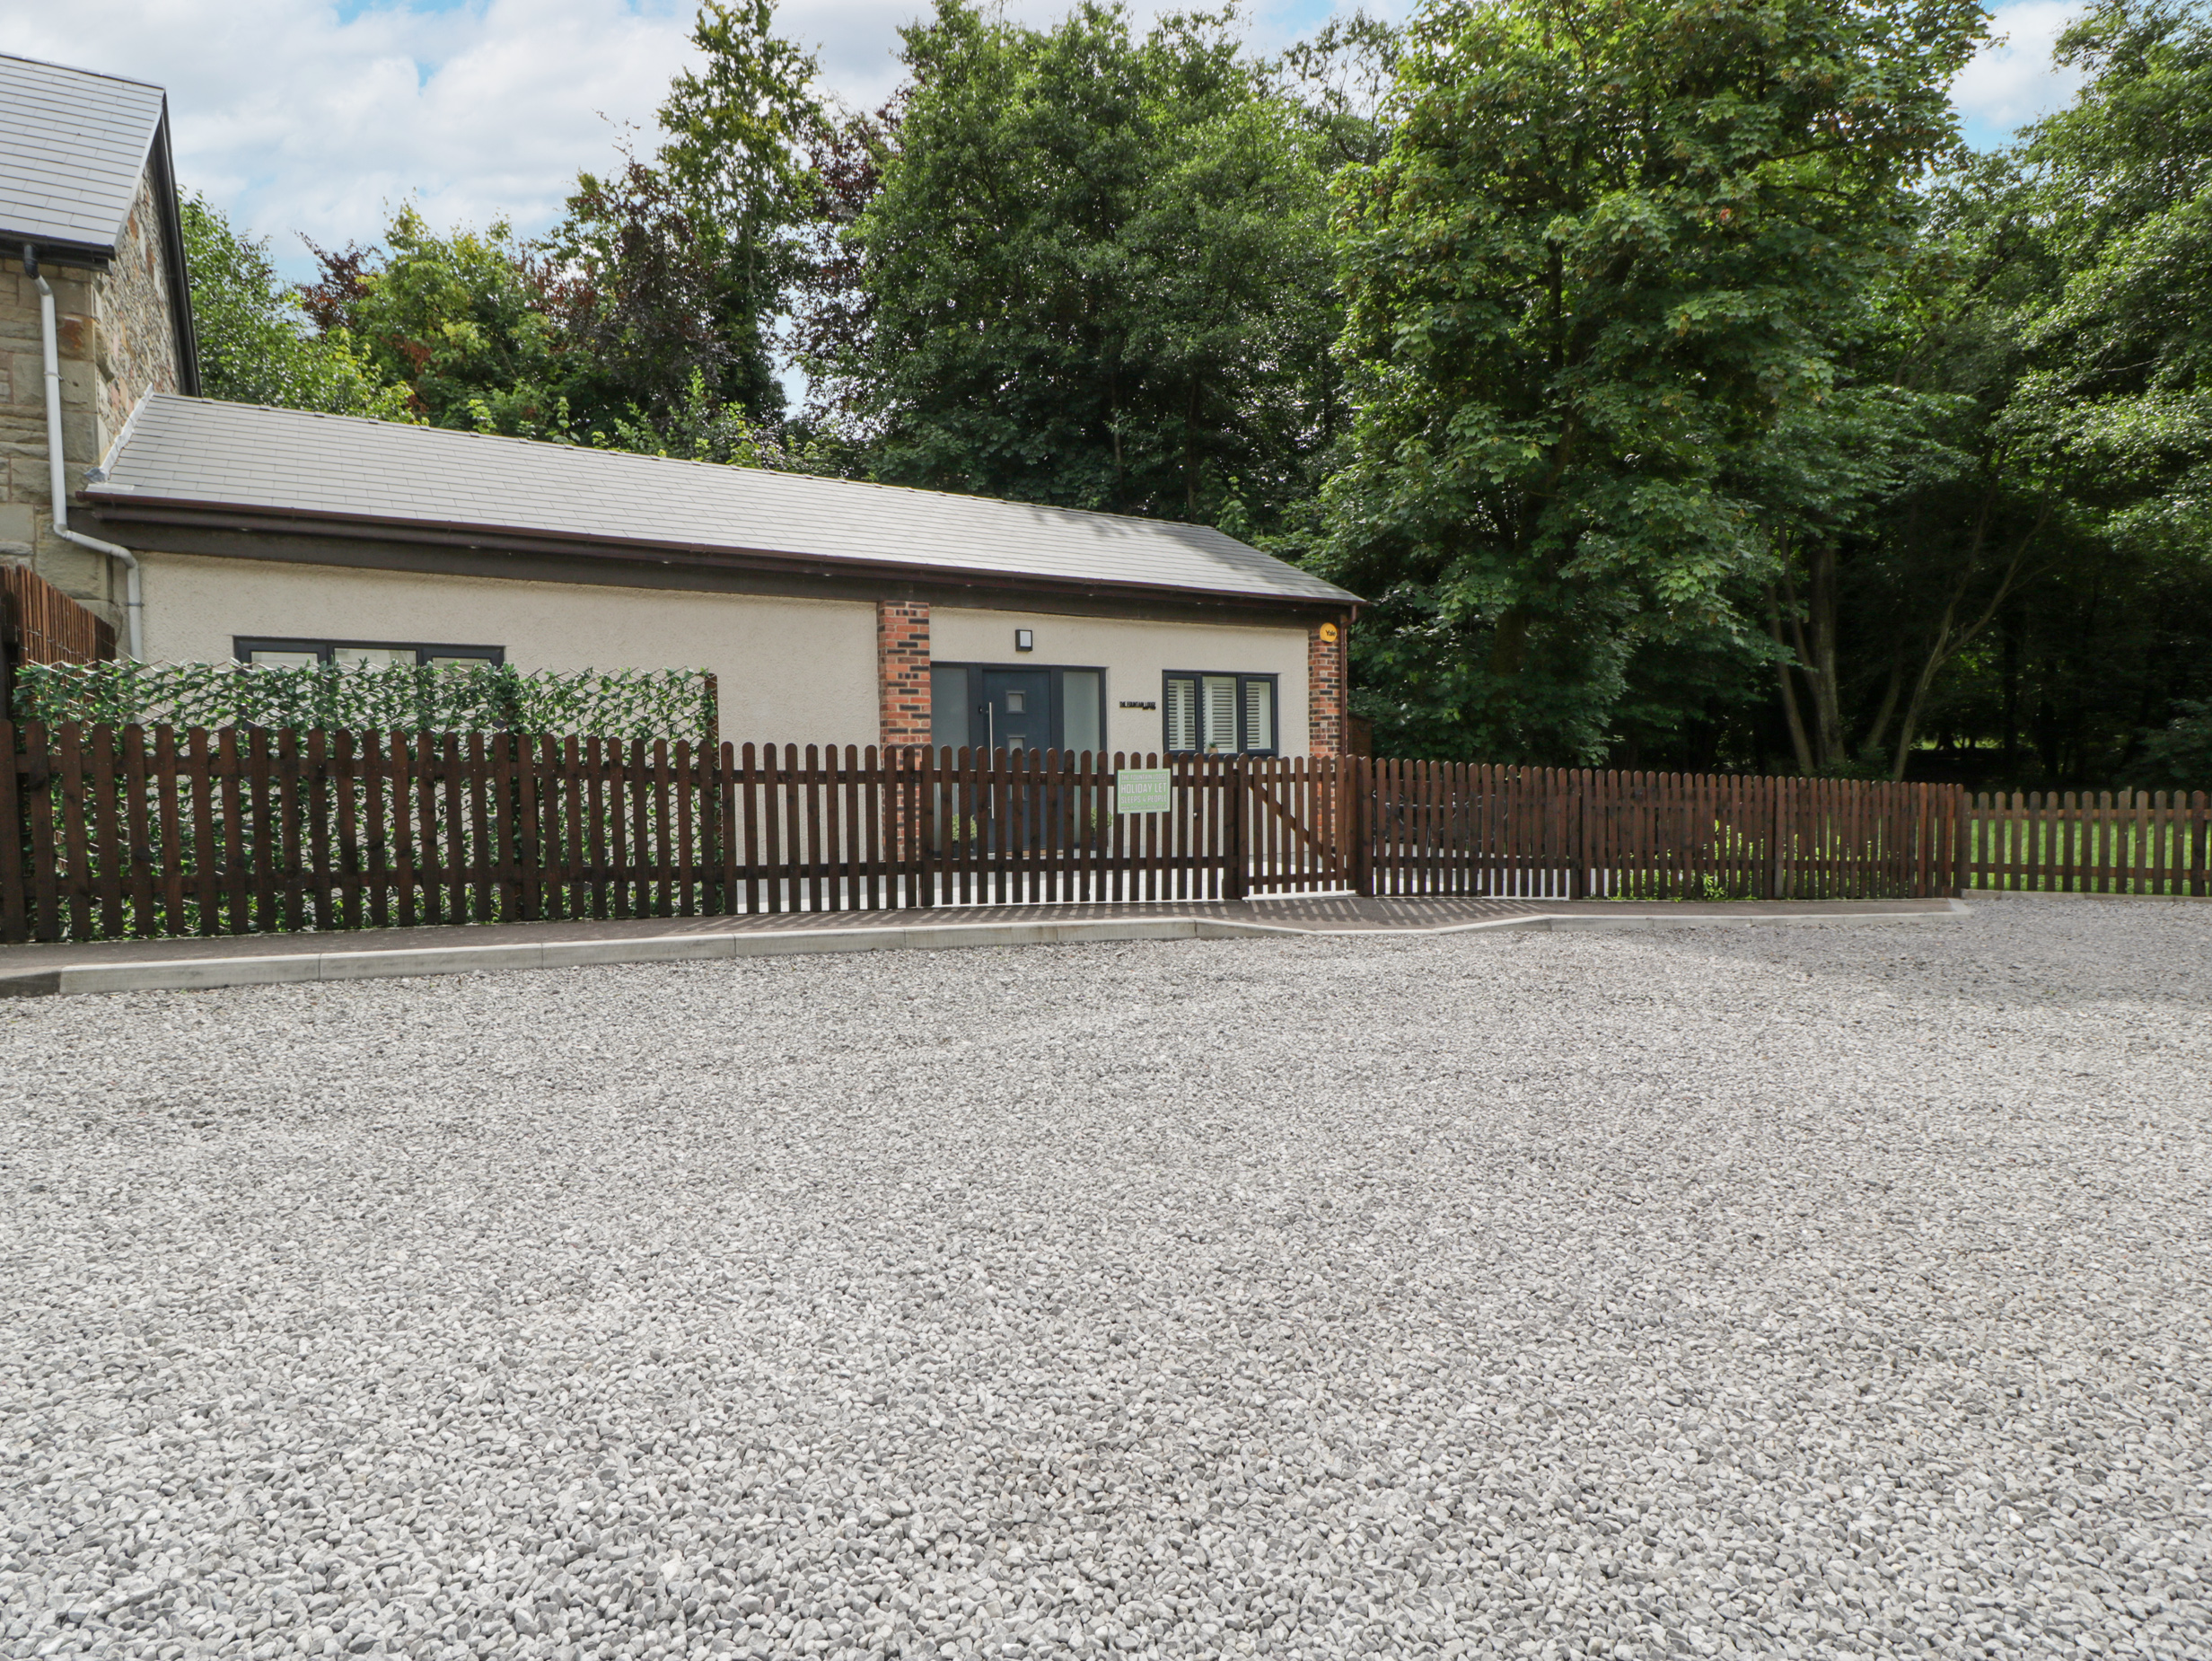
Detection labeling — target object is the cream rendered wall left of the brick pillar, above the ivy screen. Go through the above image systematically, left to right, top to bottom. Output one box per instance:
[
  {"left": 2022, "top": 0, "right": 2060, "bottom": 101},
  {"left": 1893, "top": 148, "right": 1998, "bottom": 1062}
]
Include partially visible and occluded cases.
[{"left": 139, "top": 553, "right": 880, "bottom": 743}]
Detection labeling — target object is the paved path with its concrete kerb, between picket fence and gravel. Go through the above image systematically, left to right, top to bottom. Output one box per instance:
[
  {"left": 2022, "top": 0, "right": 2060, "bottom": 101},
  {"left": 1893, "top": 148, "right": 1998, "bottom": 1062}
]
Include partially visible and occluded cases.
[{"left": 0, "top": 893, "right": 1964, "bottom": 997}]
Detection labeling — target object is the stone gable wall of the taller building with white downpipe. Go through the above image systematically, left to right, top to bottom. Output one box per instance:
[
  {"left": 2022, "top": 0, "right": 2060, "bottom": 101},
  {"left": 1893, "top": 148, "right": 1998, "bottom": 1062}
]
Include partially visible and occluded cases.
[{"left": 0, "top": 180, "right": 181, "bottom": 626}]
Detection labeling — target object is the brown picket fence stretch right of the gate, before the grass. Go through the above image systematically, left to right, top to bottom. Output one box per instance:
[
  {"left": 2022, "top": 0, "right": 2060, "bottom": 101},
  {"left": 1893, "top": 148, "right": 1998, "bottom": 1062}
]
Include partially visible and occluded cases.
[{"left": 1360, "top": 760, "right": 1960, "bottom": 901}]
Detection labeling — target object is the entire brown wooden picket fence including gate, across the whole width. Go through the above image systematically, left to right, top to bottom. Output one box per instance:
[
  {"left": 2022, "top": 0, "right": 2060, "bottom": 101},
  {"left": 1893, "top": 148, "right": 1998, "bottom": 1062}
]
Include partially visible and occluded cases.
[{"left": 0, "top": 721, "right": 2212, "bottom": 942}]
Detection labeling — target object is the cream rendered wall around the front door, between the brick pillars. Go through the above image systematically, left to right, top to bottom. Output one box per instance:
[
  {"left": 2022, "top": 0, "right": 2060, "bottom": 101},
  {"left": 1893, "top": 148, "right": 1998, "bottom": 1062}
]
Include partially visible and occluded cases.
[{"left": 929, "top": 606, "right": 1310, "bottom": 754}]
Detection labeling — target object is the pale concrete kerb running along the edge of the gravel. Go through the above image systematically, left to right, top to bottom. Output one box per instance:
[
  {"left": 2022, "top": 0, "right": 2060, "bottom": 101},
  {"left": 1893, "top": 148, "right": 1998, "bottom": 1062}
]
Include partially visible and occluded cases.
[{"left": 0, "top": 901, "right": 1969, "bottom": 997}]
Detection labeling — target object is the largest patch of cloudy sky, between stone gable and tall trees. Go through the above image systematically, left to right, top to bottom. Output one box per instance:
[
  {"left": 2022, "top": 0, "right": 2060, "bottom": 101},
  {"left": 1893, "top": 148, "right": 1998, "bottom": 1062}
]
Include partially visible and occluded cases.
[{"left": 0, "top": 0, "right": 688, "bottom": 268}]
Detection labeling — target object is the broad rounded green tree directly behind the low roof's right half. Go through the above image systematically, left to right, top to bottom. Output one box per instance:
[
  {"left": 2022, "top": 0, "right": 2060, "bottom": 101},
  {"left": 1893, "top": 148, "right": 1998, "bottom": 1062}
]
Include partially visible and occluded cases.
[{"left": 803, "top": 0, "right": 1360, "bottom": 529}]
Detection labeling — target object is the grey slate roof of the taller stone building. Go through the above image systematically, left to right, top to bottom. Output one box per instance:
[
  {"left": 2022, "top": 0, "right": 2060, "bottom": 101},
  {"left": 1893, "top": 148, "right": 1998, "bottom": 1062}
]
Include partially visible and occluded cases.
[{"left": 0, "top": 57, "right": 166, "bottom": 257}]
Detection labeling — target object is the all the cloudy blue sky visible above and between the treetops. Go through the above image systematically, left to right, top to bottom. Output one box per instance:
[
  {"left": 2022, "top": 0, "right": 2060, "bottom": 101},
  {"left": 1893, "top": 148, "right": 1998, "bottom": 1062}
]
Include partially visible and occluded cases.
[{"left": 0, "top": 0, "right": 2077, "bottom": 278}]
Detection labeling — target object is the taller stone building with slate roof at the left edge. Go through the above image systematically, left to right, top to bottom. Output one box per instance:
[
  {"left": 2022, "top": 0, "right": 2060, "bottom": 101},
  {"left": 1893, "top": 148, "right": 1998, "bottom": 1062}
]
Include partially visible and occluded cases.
[{"left": 0, "top": 57, "right": 199, "bottom": 628}]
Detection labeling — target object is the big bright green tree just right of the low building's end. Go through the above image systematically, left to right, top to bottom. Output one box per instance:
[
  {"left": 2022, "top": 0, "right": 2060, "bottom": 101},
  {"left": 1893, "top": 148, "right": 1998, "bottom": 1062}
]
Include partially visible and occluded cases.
[{"left": 1325, "top": 0, "right": 1982, "bottom": 760}]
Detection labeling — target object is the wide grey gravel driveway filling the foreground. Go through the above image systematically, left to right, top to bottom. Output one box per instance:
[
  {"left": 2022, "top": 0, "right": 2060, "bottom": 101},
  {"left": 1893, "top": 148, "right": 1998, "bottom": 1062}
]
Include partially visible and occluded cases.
[{"left": 0, "top": 901, "right": 2212, "bottom": 1659}]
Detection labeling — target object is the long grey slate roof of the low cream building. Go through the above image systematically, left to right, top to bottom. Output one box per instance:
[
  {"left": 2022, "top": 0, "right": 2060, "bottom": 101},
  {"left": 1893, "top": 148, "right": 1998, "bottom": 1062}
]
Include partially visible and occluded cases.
[{"left": 84, "top": 393, "right": 1356, "bottom": 604}]
